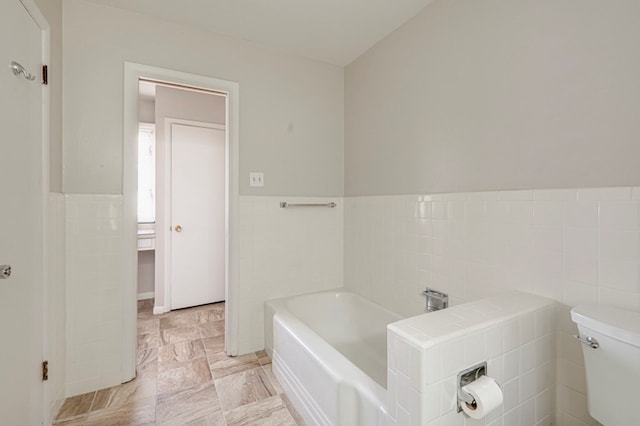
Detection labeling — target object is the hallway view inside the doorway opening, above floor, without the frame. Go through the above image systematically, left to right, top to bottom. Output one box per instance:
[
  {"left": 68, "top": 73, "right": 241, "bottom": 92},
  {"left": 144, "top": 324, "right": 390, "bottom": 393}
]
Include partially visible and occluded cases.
[{"left": 137, "top": 79, "right": 227, "bottom": 314}]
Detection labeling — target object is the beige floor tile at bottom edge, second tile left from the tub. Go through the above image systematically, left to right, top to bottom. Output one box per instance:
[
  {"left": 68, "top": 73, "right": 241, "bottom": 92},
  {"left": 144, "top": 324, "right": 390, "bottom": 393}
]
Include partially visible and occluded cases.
[{"left": 156, "top": 382, "right": 222, "bottom": 426}]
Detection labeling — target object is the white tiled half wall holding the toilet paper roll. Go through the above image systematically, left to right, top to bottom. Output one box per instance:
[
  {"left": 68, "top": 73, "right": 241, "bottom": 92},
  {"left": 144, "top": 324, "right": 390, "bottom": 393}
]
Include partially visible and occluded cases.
[{"left": 388, "top": 292, "right": 556, "bottom": 426}]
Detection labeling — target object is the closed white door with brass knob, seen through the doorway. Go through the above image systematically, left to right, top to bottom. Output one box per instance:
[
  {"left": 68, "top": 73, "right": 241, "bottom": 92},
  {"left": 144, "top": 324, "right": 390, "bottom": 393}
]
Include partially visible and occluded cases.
[{"left": 170, "top": 123, "right": 226, "bottom": 309}]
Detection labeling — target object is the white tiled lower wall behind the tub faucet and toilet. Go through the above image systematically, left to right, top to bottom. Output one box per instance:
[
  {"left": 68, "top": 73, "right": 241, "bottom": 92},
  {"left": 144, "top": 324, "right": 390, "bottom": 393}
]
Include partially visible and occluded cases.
[{"left": 344, "top": 187, "right": 640, "bottom": 425}]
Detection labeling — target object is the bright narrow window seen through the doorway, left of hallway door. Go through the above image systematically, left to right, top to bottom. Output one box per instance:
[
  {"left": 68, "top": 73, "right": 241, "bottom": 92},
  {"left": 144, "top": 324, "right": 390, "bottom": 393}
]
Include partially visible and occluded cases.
[{"left": 138, "top": 123, "right": 156, "bottom": 223}]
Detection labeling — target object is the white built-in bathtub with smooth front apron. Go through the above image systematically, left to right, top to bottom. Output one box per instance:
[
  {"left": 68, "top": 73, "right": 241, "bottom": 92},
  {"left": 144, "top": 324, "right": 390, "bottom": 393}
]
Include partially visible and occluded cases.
[{"left": 265, "top": 291, "right": 402, "bottom": 426}]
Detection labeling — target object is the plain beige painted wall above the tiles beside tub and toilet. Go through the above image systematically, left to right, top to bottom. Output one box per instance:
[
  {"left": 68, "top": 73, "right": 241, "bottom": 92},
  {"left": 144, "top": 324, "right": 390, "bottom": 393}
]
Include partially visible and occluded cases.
[{"left": 345, "top": 0, "right": 640, "bottom": 195}]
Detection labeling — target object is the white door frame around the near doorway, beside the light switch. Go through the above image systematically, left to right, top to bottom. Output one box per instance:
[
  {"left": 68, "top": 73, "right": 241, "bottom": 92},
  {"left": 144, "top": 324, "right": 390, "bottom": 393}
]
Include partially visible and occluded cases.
[{"left": 121, "top": 62, "right": 240, "bottom": 382}]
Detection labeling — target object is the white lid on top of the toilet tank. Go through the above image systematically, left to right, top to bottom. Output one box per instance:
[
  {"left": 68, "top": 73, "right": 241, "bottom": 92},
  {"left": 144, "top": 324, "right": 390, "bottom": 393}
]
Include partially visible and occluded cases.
[{"left": 571, "top": 305, "right": 640, "bottom": 347}]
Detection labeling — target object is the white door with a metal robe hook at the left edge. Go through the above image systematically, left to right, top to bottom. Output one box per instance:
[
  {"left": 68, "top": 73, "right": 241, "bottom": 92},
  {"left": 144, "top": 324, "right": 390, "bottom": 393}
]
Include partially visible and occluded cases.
[{"left": 0, "top": 0, "right": 43, "bottom": 425}]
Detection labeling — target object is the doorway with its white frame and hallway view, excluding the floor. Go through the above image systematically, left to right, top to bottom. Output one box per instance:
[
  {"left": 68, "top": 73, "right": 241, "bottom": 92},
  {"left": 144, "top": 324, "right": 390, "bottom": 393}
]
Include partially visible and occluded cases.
[{"left": 123, "top": 63, "right": 239, "bottom": 382}]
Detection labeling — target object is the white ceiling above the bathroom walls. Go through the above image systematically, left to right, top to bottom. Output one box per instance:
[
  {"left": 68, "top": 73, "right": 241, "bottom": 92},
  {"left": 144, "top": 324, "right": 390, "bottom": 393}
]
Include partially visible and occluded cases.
[{"left": 82, "top": 0, "right": 432, "bottom": 66}]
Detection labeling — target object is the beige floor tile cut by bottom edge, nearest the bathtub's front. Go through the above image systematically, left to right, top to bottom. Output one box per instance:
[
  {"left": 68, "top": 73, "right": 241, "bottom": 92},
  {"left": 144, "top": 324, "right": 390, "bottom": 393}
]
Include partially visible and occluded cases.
[{"left": 224, "top": 395, "right": 296, "bottom": 426}]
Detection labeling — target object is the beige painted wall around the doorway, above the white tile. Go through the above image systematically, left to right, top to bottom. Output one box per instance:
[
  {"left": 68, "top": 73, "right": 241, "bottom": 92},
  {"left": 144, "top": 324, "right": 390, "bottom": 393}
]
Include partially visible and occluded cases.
[{"left": 64, "top": 0, "right": 344, "bottom": 195}]
